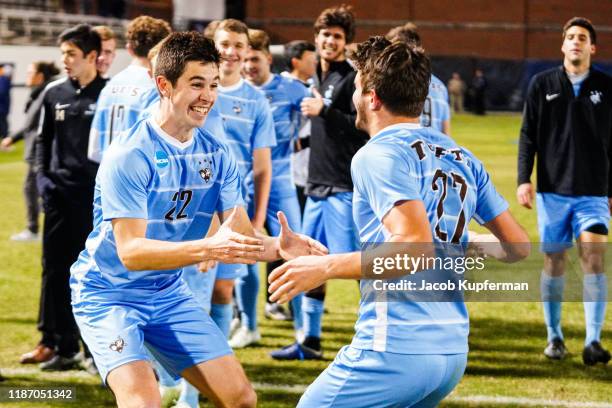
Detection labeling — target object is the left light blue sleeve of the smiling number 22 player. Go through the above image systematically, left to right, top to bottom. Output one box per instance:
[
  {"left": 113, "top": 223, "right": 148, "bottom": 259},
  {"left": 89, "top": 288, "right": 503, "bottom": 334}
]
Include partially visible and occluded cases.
[{"left": 98, "top": 148, "right": 153, "bottom": 220}]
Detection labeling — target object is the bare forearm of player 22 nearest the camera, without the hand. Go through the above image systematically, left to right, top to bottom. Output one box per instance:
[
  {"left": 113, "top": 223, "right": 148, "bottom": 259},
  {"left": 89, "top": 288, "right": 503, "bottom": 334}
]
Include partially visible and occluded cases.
[{"left": 117, "top": 238, "right": 209, "bottom": 271}]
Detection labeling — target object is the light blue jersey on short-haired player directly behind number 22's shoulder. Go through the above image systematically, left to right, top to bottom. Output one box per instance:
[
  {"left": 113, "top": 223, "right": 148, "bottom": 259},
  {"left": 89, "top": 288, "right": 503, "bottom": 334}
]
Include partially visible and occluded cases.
[{"left": 213, "top": 79, "right": 276, "bottom": 197}]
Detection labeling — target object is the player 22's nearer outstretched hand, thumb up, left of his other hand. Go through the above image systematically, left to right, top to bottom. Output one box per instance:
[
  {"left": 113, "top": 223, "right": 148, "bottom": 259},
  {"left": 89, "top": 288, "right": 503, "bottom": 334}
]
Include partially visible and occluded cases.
[{"left": 204, "top": 207, "right": 264, "bottom": 264}]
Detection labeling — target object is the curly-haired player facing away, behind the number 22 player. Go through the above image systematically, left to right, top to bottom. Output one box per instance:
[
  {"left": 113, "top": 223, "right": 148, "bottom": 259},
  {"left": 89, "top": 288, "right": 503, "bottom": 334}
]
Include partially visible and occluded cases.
[{"left": 87, "top": 16, "right": 171, "bottom": 163}]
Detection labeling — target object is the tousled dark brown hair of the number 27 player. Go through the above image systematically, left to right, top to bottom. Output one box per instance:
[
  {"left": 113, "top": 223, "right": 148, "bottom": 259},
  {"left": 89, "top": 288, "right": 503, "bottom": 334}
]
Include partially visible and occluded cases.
[{"left": 349, "top": 36, "right": 431, "bottom": 118}]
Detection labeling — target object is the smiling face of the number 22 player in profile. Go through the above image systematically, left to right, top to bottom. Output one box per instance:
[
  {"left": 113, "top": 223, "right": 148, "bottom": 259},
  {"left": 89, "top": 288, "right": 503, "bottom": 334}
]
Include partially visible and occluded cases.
[{"left": 156, "top": 61, "right": 219, "bottom": 130}]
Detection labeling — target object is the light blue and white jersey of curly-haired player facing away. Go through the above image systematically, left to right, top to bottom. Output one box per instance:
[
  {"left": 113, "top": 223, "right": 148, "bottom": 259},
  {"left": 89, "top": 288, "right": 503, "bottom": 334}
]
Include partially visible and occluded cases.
[{"left": 87, "top": 65, "right": 159, "bottom": 163}]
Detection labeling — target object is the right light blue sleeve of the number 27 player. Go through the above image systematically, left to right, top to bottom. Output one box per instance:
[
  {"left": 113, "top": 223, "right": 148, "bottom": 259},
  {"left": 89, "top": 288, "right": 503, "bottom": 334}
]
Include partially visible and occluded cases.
[{"left": 472, "top": 154, "right": 508, "bottom": 224}]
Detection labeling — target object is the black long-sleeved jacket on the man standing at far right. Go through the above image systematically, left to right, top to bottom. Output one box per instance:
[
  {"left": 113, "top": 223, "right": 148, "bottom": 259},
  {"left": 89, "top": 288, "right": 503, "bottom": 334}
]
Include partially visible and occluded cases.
[{"left": 518, "top": 67, "right": 612, "bottom": 196}]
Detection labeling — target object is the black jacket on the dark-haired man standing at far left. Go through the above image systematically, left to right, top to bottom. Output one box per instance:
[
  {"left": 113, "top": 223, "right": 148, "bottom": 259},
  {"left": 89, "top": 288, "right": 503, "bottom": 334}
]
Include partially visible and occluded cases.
[{"left": 36, "top": 75, "right": 107, "bottom": 190}]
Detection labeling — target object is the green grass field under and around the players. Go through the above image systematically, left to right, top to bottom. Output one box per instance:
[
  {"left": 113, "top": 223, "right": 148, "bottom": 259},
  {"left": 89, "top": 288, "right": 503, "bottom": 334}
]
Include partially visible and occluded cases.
[{"left": 0, "top": 115, "right": 612, "bottom": 407}]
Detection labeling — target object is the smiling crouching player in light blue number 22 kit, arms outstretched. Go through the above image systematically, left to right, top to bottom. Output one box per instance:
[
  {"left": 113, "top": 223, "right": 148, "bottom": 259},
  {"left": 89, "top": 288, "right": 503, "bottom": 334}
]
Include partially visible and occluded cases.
[{"left": 70, "top": 32, "right": 325, "bottom": 407}]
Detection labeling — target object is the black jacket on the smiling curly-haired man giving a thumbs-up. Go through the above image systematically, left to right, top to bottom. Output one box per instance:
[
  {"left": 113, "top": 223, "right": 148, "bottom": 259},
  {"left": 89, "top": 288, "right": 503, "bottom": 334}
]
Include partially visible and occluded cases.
[{"left": 306, "top": 61, "right": 368, "bottom": 197}]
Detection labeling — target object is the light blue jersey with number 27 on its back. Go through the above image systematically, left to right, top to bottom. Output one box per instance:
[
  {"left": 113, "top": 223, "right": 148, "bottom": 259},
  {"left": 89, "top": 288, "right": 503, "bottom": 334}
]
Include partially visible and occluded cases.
[{"left": 351, "top": 124, "right": 508, "bottom": 354}]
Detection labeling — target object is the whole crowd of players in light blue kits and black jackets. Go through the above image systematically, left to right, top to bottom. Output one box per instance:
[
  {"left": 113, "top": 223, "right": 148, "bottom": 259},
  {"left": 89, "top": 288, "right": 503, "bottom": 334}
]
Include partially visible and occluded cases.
[{"left": 2, "top": 6, "right": 612, "bottom": 407}]
